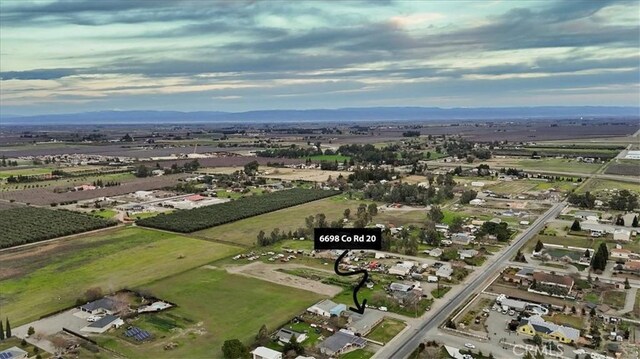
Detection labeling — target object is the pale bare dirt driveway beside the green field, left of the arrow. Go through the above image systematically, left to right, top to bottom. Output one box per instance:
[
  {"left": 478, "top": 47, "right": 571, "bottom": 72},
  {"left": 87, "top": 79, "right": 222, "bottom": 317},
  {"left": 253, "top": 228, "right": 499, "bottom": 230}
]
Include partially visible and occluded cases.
[{"left": 226, "top": 262, "right": 342, "bottom": 297}]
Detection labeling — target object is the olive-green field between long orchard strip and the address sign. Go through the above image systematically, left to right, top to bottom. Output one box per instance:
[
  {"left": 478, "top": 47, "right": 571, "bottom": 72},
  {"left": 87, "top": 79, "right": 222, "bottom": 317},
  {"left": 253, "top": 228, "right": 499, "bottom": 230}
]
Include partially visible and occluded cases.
[{"left": 193, "top": 195, "right": 376, "bottom": 246}]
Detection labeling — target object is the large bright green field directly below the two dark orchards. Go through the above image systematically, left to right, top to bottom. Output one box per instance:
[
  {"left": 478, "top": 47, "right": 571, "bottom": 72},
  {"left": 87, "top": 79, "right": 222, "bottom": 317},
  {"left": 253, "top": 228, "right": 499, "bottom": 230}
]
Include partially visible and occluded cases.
[{"left": 0, "top": 227, "right": 240, "bottom": 326}]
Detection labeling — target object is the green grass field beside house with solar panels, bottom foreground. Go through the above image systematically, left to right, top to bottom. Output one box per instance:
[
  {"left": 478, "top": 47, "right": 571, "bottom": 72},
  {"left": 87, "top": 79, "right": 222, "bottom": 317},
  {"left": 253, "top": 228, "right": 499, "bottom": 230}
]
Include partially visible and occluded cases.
[{"left": 98, "top": 267, "right": 322, "bottom": 358}]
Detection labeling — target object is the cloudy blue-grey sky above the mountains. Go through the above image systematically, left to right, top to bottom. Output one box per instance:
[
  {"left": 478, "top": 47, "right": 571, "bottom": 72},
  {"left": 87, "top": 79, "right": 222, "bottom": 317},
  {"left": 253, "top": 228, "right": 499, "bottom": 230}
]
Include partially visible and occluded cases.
[{"left": 0, "top": 0, "right": 640, "bottom": 115}]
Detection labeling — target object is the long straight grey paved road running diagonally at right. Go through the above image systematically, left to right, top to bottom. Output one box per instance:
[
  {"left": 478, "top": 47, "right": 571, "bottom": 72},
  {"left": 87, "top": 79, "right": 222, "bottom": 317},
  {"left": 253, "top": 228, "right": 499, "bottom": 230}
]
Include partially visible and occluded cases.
[{"left": 373, "top": 203, "right": 566, "bottom": 359}]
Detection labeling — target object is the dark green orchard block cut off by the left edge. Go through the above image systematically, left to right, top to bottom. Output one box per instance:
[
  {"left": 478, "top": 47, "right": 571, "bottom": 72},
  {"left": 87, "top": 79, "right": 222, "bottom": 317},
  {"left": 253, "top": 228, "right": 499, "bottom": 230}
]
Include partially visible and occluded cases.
[{"left": 0, "top": 207, "right": 116, "bottom": 248}]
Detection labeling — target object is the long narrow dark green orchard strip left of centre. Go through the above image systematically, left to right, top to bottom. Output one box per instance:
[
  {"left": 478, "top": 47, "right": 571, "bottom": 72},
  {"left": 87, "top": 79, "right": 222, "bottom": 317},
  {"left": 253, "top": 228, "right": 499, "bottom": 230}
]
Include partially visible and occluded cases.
[{"left": 137, "top": 188, "right": 338, "bottom": 233}]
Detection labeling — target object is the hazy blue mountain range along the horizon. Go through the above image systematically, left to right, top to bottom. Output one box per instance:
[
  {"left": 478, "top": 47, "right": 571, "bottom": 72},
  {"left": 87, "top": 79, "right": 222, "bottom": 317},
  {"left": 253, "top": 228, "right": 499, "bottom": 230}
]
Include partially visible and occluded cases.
[{"left": 0, "top": 106, "right": 640, "bottom": 125}]
